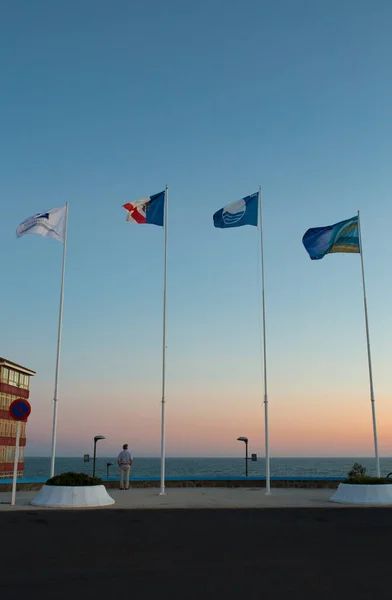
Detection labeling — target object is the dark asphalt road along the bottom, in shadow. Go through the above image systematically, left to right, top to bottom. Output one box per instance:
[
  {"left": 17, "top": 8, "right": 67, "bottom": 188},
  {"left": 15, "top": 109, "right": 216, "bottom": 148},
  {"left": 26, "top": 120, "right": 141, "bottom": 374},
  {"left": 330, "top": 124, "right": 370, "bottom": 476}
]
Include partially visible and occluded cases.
[{"left": 0, "top": 508, "right": 392, "bottom": 600}]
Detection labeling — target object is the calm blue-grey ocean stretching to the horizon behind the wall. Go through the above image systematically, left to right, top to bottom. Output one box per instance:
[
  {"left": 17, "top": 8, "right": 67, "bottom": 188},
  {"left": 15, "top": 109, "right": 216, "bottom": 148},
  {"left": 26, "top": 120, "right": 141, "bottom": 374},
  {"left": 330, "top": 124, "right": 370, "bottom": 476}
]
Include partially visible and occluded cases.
[{"left": 24, "top": 457, "right": 392, "bottom": 478}]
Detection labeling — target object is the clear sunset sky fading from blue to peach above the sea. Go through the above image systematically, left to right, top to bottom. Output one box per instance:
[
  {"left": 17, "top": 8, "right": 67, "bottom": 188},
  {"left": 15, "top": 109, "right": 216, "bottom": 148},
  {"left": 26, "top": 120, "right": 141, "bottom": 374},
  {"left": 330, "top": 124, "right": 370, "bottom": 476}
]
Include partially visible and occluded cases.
[{"left": 0, "top": 0, "right": 392, "bottom": 457}]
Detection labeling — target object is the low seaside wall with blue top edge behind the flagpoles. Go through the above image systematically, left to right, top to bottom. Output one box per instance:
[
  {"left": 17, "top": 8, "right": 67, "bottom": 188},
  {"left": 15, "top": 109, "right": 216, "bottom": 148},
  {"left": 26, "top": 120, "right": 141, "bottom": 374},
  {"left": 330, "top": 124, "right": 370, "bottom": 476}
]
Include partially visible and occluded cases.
[{"left": 0, "top": 477, "right": 344, "bottom": 492}]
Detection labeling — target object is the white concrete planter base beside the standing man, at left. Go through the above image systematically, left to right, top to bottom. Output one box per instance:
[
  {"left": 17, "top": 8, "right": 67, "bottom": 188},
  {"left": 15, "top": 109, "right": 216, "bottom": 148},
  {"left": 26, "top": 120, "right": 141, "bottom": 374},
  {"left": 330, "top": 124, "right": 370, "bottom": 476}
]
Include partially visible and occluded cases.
[{"left": 31, "top": 485, "right": 114, "bottom": 508}]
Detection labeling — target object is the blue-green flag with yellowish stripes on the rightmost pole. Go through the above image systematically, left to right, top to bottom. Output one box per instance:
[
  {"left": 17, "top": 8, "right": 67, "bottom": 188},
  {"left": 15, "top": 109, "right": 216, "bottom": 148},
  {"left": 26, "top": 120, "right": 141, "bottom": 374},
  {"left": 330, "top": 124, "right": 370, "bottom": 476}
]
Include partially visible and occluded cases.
[{"left": 302, "top": 217, "right": 360, "bottom": 260}]
